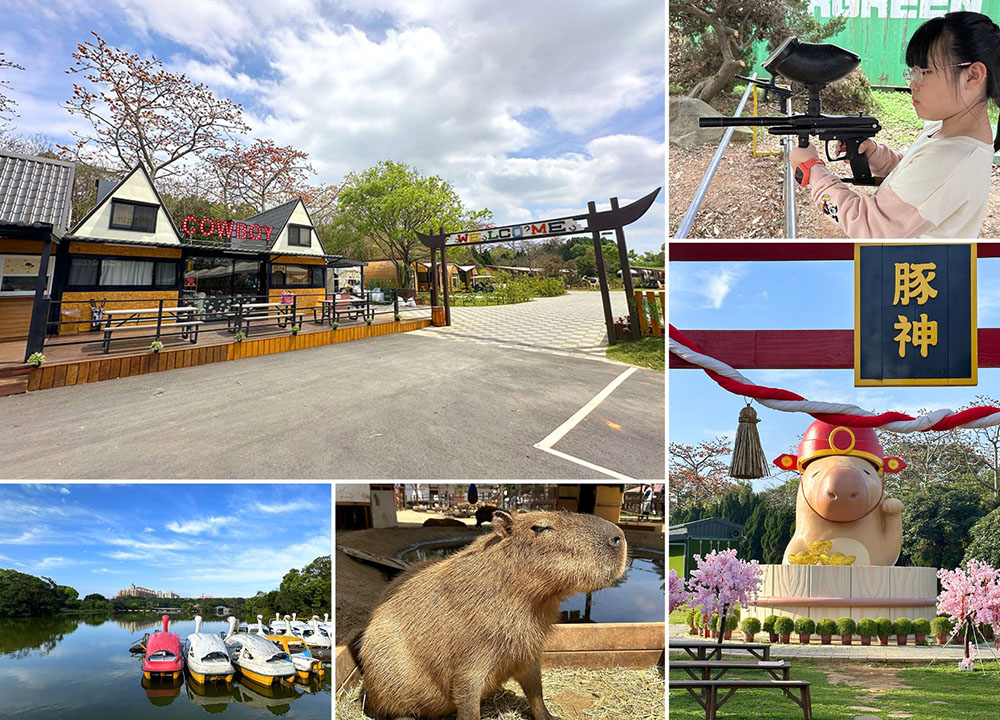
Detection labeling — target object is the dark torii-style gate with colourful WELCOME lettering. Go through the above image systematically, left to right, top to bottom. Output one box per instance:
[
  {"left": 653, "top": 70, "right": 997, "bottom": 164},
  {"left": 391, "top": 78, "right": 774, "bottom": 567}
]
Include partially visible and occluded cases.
[{"left": 417, "top": 188, "right": 661, "bottom": 345}]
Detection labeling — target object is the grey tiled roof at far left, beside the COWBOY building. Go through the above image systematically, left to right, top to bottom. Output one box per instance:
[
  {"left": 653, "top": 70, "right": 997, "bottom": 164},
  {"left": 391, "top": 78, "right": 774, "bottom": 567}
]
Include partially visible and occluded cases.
[{"left": 0, "top": 152, "right": 76, "bottom": 236}]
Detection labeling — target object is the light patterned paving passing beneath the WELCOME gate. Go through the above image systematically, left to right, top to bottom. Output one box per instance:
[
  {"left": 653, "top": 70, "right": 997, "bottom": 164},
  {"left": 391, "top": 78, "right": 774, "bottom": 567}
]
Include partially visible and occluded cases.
[{"left": 408, "top": 291, "right": 628, "bottom": 359}]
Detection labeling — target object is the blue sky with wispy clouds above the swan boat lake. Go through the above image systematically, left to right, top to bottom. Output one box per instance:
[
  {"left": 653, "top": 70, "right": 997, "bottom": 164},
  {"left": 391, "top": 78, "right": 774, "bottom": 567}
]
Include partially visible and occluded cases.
[{"left": 0, "top": 483, "right": 331, "bottom": 598}]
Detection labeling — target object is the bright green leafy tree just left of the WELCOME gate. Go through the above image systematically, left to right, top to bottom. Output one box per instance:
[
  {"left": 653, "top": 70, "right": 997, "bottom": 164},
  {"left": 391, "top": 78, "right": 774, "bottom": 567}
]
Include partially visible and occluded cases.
[{"left": 337, "top": 160, "right": 492, "bottom": 287}]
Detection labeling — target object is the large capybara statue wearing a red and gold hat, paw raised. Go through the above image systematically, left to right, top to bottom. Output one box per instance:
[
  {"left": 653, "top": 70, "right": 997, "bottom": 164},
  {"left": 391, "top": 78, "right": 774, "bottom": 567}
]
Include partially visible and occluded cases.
[{"left": 774, "top": 420, "right": 906, "bottom": 565}]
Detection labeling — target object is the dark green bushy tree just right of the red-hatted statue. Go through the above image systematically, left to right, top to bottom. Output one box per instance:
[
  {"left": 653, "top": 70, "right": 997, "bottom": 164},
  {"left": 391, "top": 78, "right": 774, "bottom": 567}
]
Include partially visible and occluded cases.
[{"left": 900, "top": 483, "right": 985, "bottom": 568}]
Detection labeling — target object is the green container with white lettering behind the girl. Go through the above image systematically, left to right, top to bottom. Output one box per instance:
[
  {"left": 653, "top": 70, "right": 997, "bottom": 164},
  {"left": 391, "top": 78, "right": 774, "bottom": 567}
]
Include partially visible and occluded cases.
[{"left": 754, "top": 0, "right": 1000, "bottom": 88}]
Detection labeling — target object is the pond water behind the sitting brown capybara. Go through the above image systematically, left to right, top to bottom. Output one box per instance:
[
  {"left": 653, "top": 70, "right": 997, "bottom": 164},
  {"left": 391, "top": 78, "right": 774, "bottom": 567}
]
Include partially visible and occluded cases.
[{"left": 400, "top": 541, "right": 666, "bottom": 623}]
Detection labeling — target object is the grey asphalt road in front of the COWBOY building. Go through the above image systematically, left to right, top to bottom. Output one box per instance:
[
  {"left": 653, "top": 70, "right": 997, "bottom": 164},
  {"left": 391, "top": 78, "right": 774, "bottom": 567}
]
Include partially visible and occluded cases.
[{"left": 0, "top": 324, "right": 665, "bottom": 480}]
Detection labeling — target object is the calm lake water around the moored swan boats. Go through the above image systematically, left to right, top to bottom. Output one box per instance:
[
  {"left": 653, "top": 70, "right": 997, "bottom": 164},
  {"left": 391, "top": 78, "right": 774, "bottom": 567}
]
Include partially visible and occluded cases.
[{"left": 0, "top": 613, "right": 333, "bottom": 720}]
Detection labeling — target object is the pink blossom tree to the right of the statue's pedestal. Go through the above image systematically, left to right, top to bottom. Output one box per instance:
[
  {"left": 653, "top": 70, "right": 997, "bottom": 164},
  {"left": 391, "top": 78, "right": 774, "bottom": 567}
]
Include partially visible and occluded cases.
[{"left": 937, "top": 560, "right": 1000, "bottom": 669}]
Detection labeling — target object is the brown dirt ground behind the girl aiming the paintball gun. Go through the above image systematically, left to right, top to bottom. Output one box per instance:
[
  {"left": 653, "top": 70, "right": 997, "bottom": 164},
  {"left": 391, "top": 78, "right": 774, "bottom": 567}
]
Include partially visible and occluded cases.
[{"left": 668, "top": 136, "right": 1000, "bottom": 239}]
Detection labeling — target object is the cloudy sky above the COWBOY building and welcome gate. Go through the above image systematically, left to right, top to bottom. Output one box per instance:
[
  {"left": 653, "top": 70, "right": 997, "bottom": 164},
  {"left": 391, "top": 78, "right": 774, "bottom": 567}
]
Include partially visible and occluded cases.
[{"left": 0, "top": 0, "right": 665, "bottom": 252}]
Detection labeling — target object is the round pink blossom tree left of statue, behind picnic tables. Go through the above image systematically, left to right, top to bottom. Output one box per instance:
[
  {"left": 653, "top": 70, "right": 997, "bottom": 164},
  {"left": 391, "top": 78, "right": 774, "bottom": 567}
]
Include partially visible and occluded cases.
[{"left": 688, "top": 550, "right": 763, "bottom": 644}]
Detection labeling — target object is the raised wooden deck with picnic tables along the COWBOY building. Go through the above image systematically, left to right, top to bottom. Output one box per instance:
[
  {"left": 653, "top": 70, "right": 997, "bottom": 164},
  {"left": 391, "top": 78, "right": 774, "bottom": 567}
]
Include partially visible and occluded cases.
[{"left": 0, "top": 313, "right": 431, "bottom": 392}]
